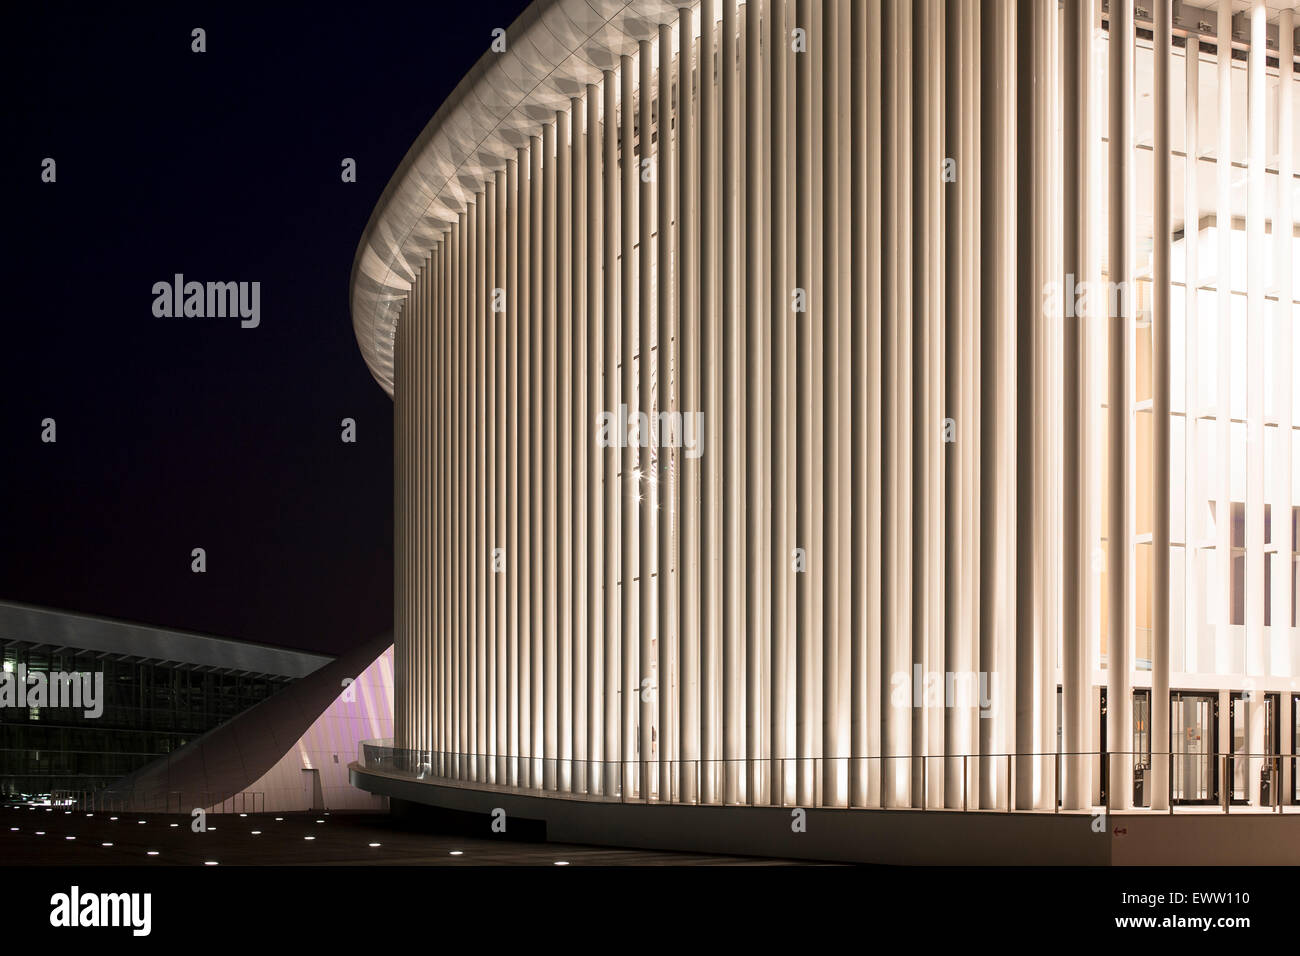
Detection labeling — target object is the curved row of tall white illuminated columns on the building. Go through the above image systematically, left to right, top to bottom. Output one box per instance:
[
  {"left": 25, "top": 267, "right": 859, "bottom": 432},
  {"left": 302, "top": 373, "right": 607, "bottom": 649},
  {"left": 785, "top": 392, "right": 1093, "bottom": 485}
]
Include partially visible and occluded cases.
[{"left": 394, "top": 0, "right": 1291, "bottom": 809}]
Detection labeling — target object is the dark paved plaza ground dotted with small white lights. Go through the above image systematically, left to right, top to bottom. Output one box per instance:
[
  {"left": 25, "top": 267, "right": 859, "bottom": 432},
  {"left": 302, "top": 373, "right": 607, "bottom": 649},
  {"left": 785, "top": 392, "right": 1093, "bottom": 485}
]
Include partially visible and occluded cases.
[{"left": 0, "top": 808, "right": 789, "bottom": 866}]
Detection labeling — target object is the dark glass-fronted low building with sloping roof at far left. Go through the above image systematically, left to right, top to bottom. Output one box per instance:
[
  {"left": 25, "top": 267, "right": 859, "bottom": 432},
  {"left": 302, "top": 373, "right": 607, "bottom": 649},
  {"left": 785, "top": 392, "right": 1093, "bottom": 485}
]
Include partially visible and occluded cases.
[{"left": 0, "top": 602, "right": 330, "bottom": 800}]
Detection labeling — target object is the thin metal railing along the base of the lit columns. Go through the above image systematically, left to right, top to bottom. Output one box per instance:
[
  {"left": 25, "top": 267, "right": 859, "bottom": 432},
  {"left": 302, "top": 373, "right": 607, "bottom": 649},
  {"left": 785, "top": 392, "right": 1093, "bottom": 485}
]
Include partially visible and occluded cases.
[{"left": 358, "top": 740, "right": 1292, "bottom": 813}]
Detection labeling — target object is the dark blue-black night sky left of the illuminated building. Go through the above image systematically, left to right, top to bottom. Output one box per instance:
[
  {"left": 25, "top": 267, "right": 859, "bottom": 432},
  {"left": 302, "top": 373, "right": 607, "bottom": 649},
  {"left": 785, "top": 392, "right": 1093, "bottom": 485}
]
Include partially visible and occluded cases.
[{"left": 0, "top": 0, "right": 525, "bottom": 653}]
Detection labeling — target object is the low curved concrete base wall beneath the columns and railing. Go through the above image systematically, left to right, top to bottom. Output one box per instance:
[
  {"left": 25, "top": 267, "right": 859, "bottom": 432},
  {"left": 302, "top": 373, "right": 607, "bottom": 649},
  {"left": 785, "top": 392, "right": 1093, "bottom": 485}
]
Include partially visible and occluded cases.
[{"left": 351, "top": 766, "right": 1300, "bottom": 866}]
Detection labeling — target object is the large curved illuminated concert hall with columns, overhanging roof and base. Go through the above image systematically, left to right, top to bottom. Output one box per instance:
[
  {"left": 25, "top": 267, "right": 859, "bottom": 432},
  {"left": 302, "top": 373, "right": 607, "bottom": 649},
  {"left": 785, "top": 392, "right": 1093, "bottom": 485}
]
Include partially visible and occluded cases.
[{"left": 351, "top": 0, "right": 1300, "bottom": 862}]
